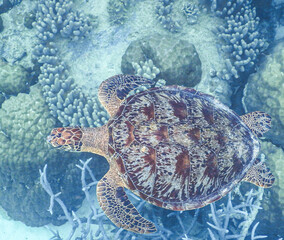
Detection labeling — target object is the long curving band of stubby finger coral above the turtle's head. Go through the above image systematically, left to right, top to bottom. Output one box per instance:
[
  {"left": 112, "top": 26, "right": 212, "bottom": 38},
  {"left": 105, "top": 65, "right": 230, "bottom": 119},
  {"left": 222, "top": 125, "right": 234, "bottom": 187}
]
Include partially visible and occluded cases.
[{"left": 33, "top": 0, "right": 108, "bottom": 126}]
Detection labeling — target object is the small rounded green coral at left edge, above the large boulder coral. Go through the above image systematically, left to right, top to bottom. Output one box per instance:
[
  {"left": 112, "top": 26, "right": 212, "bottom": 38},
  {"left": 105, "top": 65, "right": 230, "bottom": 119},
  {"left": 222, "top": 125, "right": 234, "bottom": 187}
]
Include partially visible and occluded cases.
[{"left": 0, "top": 59, "right": 31, "bottom": 95}]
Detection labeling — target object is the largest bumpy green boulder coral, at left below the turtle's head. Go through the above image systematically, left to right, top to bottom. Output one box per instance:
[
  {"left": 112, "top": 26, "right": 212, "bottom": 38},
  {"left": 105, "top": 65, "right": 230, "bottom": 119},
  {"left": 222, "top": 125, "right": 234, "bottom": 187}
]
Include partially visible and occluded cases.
[{"left": 0, "top": 86, "right": 86, "bottom": 226}]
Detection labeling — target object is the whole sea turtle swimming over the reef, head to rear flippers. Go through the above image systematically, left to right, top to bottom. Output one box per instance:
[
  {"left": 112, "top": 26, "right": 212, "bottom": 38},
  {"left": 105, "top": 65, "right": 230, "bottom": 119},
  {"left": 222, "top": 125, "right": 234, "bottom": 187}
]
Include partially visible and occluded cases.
[{"left": 48, "top": 75, "right": 274, "bottom": 233}]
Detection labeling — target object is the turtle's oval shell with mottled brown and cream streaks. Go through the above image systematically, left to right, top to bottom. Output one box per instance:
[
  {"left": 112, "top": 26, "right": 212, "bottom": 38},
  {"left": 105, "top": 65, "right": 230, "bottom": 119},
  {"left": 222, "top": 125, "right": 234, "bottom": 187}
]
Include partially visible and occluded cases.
[{"left": 108, "top": 87, "right": 259, "bottom": 210}]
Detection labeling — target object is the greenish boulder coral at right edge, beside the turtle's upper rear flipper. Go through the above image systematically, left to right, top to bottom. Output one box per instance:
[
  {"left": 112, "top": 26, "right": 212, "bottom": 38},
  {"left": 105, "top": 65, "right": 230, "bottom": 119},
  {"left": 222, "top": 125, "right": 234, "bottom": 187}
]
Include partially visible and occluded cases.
[{"left": 243, "top": 42, "right": 284, "bottom": 146}]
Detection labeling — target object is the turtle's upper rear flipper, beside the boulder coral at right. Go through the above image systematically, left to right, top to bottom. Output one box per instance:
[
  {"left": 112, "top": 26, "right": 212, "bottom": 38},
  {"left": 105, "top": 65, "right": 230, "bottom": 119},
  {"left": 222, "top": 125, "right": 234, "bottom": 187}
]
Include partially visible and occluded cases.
[{"left": 240, "top": 111, "right": 271, "bottom": 137}]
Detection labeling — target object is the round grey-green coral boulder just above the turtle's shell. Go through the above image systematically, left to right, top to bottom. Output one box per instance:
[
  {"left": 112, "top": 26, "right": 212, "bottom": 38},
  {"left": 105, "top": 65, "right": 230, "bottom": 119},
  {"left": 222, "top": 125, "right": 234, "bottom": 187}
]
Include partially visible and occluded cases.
[{"left": 121, "top": 35, "right": 202, "bottom": 87}]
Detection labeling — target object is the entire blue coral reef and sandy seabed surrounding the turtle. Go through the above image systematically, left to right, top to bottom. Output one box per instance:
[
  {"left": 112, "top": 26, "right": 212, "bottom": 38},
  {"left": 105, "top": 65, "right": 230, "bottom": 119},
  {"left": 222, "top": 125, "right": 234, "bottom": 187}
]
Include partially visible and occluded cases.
[{"left": 0, "top": 0, "right": 284, "bottom": 240}]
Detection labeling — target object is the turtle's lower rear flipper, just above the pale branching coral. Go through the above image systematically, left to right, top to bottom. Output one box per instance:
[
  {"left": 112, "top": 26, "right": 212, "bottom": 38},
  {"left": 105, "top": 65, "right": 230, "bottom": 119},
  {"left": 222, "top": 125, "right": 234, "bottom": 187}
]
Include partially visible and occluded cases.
[{"left": 243, "top": 159, "right": 275, "bottom": 188}]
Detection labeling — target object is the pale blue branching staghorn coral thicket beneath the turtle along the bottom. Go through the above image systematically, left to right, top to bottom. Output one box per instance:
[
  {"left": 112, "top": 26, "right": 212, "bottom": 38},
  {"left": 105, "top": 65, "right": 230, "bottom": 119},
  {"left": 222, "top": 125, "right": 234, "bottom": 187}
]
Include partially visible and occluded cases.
[{"left": 41, "top": 158, "right": 267, "bottom": 240}]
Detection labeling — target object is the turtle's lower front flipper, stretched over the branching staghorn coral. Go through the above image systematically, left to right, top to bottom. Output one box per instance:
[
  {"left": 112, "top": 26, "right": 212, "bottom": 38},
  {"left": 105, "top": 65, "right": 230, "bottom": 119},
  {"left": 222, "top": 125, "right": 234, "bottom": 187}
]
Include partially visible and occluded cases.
[{"left": 97, "top": 169, "right": 156, "bottom": 234}]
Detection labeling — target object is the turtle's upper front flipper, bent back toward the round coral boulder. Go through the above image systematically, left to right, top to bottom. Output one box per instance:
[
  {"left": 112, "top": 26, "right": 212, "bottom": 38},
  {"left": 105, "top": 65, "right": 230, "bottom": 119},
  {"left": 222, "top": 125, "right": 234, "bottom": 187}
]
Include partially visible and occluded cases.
[{"left": 98, "top": 74, "right": 152, "bottom": 117}]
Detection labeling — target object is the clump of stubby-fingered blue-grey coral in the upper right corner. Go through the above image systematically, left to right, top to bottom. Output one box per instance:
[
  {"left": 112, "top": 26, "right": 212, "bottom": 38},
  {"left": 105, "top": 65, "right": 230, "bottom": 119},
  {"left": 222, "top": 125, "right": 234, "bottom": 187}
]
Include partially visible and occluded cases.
[{"left": 216, "top": 0, "right": 267, "bottom": 80}]
